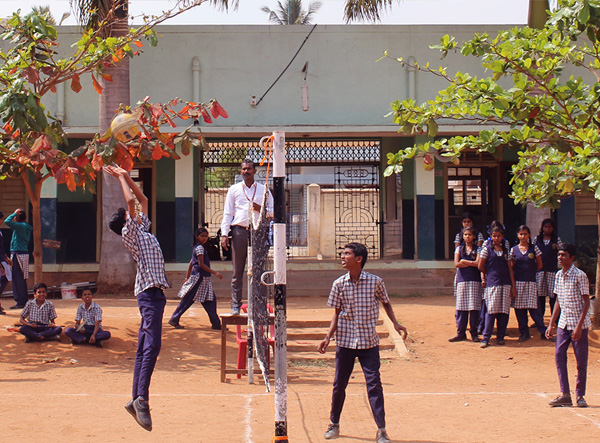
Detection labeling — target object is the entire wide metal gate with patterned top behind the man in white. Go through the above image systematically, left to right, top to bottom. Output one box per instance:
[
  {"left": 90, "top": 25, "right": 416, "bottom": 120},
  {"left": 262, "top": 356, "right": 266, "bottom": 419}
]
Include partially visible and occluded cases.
[{"left": 199, "top": 140, "right": 380, "bottom": 258}]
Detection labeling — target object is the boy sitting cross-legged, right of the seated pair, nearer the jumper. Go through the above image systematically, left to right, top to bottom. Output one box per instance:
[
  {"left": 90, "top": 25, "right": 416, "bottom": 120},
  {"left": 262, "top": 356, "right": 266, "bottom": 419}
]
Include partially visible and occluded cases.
[{"left": 65, "top": 289, "right": 110, "bottom": 348}]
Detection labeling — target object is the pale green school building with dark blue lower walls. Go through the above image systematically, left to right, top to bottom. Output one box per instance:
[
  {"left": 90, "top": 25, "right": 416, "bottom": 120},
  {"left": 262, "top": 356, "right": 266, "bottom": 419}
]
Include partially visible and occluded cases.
[{"left": 0, "top": 24, "right": 598, "bottom": 270}]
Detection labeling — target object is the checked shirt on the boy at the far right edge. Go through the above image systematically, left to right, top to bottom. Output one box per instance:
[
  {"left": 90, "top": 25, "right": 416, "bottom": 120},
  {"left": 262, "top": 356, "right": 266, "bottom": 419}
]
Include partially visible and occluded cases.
[{"left": 554, "top": 265, "right": 592, "bottom": 331}]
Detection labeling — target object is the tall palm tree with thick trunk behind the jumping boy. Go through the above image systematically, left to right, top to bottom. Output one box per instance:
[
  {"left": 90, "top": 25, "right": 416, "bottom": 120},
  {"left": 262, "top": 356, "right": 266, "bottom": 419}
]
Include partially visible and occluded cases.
[{"left": 70, "top": 0, "right": 238, "bottom": 292}]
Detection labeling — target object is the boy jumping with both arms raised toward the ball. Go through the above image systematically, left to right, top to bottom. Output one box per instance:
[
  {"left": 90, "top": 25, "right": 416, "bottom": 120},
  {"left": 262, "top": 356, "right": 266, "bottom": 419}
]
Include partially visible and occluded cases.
[{"left": 104, "top": 166, "right": 169, "bottom": 431}]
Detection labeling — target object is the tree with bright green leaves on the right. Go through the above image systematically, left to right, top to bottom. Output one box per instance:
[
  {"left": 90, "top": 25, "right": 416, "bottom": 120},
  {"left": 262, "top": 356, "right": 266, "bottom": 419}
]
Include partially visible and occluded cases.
[{"left": 385, "top": 0, "right": 600, "bottom": 322}]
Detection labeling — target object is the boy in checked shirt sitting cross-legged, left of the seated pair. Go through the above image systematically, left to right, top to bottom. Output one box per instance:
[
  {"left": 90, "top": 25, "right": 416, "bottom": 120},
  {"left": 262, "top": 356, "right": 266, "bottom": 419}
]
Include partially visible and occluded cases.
[{"left": 19, "top": 283, "right": 62, "bottom": 343}]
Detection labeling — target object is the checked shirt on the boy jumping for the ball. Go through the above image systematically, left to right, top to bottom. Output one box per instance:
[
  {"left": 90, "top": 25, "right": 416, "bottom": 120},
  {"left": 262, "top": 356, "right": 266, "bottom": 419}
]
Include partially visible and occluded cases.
[{"left": 121, "top": 212, "right": 169, "bottom": 296}]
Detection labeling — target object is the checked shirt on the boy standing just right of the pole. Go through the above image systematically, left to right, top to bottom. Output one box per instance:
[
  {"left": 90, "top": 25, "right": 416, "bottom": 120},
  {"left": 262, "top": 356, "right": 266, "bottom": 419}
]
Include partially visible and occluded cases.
[{"left": 327, "top": 271, "right": 390, "bottom": 349}]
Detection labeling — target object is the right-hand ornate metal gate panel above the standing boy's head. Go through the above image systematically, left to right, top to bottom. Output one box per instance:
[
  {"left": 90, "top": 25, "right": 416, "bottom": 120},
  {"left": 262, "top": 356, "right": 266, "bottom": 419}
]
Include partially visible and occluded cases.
[{"left": 334, "top": 165, "right": 380, "bottom": 258}]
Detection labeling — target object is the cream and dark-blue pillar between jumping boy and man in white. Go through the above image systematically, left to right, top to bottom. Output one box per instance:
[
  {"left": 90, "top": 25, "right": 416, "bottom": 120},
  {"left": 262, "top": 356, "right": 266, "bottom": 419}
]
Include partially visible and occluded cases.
[{"left": 175, "top": 152, "right": 195, "bottom": 263}]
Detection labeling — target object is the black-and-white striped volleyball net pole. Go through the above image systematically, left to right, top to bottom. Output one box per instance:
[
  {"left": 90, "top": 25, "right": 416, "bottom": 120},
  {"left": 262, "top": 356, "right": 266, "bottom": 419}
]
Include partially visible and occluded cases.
[{"left": 273, "top": 131, "right": 288, "bottom": 442}]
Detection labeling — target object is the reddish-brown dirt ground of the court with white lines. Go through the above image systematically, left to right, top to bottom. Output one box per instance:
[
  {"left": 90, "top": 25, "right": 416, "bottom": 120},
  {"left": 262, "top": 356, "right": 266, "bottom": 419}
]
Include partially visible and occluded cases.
[{"left": 0, "top": 297, "right": 600, "bottom": 443}]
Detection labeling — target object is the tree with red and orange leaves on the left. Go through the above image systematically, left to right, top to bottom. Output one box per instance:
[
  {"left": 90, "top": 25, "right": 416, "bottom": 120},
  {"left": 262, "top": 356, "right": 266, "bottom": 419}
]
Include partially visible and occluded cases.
[{"left": 0, "top": 6, "right": 226, "bottom": 281}]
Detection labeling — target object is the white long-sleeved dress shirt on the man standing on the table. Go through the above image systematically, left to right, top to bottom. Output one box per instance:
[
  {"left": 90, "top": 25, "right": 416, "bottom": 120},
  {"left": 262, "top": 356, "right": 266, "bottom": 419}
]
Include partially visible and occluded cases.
[{"left": 221, "top": 181, "right": 273, "bottom": 235}]
